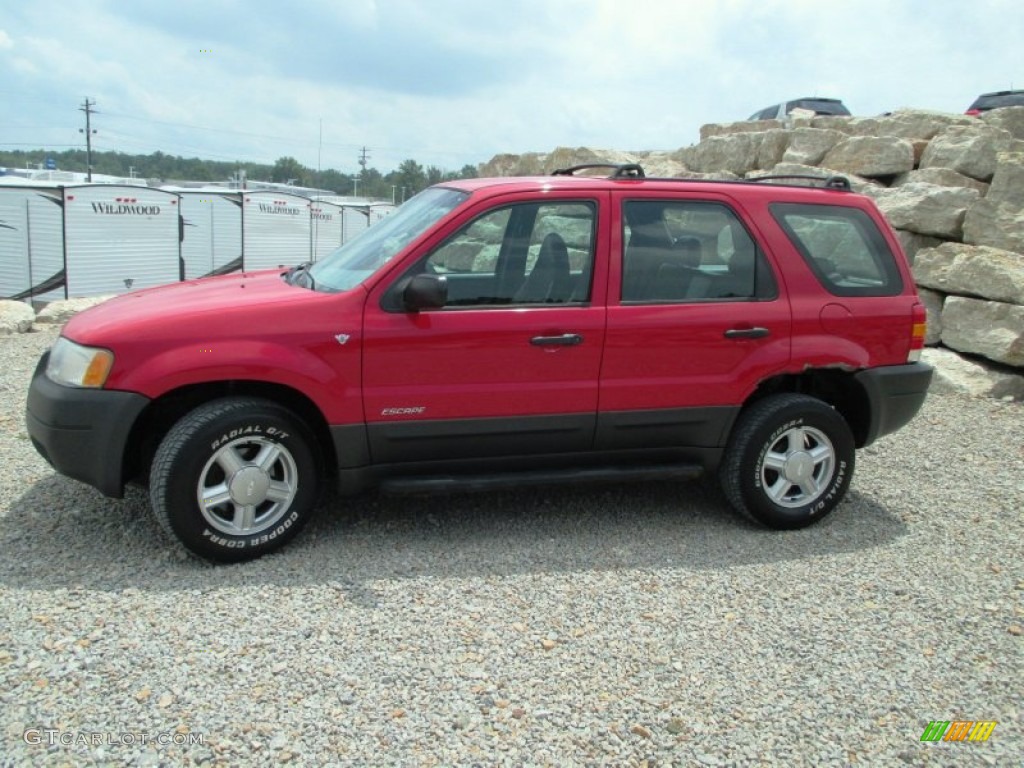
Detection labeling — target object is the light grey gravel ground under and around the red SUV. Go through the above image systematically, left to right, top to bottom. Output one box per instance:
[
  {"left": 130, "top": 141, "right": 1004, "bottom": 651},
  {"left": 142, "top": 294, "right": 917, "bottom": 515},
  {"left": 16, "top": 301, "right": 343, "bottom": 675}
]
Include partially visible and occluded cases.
[{"left": 0, "top": 331, "right": 1024, "bottom": 766}]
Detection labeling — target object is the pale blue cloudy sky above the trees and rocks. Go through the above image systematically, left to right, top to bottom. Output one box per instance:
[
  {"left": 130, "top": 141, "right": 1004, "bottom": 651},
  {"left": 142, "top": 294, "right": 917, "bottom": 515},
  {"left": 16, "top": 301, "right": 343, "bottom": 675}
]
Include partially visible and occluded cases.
[{"left": 0, "top": 0, "right": 1024, "bottom": 173}]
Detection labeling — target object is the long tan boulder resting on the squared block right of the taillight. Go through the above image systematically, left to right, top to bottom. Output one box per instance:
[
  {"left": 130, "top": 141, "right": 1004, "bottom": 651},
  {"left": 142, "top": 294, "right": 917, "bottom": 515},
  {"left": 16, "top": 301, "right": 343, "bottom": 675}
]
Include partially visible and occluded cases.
[{"left": 913, "top": 243, "right": 1024, "bottom": 304}]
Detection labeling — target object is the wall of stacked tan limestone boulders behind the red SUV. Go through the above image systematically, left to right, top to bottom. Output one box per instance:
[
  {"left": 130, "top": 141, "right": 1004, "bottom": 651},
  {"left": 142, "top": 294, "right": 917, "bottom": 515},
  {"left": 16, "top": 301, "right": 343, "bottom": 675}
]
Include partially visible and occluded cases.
[{"left": 480, "top": 106, "right": 1024, "bottom": 399}]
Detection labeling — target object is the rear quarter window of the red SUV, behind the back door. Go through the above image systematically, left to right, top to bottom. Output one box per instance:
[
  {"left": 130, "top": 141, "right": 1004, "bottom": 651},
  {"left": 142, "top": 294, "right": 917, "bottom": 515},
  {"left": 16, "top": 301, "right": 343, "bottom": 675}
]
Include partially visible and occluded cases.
[{"left": 770, "top": 203, "right": 903, "bottom": 296}]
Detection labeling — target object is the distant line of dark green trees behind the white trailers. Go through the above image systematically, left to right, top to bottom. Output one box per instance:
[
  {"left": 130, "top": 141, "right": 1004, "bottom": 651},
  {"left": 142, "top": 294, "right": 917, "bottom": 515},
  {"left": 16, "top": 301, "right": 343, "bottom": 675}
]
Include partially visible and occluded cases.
[{"left": 0, "top": 150, "right": 477, "bottom": 203}]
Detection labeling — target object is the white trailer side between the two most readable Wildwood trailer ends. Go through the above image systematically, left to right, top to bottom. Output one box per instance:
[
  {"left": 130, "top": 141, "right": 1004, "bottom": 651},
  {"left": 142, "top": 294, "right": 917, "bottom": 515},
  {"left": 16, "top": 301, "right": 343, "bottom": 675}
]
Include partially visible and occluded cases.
[{"left": 177, "top": 187, "right": 242, "bottom": 280}]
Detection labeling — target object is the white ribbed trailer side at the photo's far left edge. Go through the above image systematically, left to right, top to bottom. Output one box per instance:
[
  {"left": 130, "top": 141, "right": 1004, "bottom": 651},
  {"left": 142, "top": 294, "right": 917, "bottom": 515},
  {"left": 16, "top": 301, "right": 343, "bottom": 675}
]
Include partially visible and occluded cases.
[{"left": 0, "top": 182, "right": 66, "bottom": 301}]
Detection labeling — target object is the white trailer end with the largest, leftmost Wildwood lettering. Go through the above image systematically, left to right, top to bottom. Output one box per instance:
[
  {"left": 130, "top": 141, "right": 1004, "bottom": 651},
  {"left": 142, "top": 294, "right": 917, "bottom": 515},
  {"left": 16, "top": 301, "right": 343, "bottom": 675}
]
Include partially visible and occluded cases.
[{"left": 63, "top": 184, "right": 182, "bottom": 297}]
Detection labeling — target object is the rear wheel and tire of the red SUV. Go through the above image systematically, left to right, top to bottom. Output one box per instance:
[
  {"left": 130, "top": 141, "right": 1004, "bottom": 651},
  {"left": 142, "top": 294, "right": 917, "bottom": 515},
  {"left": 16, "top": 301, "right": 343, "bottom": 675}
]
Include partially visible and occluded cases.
[{"left": 719, "top": 394, "right": 856, "bottom": 528}]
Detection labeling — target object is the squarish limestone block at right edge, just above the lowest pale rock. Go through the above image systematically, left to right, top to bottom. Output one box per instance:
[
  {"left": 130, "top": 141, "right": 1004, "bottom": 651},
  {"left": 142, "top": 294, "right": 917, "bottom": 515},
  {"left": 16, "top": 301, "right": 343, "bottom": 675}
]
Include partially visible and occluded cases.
[{"left": 942, "top": 296, "right": 1024, "bottom": 368}]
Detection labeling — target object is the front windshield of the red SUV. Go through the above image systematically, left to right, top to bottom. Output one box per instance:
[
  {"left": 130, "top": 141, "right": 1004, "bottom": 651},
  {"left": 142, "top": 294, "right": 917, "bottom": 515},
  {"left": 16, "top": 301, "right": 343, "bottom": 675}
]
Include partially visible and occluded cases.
[{"left": 308, "top": 186, "right": 469, "bottom": 292}]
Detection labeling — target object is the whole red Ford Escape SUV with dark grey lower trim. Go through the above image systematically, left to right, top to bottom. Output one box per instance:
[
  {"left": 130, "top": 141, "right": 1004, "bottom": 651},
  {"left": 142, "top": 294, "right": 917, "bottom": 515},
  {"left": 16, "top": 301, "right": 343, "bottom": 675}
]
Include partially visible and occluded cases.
[{"left": 27, "top": 165, "right": 932, "bottom": 560}]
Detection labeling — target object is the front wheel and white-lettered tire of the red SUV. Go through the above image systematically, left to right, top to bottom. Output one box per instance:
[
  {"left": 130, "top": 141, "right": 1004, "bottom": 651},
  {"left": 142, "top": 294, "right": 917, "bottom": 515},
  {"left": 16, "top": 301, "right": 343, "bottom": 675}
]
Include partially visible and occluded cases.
[{"left": 150, "top": 397, "right": 319, "bottom": 562}]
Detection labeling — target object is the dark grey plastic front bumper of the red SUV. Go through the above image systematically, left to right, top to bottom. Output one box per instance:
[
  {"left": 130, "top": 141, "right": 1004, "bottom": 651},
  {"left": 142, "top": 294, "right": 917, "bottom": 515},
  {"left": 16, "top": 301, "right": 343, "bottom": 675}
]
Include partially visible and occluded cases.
[{"left": 25, "top": 352, "right": 150, "bottom": 499}]
